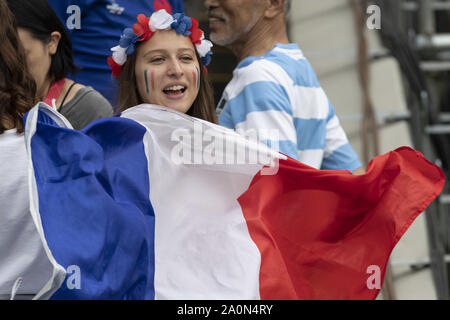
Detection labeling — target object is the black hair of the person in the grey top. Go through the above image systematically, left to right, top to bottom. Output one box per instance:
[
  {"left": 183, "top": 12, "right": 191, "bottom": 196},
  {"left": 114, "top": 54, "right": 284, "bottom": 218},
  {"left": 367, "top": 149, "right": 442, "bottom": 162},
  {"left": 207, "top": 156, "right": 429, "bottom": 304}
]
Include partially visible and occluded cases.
[{"left": 6, "top": 0, "right": 78, "bottom": 81}]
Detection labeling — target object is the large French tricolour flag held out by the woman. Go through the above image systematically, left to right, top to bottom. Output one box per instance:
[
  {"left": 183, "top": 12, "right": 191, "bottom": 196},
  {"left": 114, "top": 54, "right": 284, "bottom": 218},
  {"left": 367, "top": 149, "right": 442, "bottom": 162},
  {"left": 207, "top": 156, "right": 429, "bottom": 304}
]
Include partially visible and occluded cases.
[{"left": 25, "top": 103, "right": 444, "bottom": 300}]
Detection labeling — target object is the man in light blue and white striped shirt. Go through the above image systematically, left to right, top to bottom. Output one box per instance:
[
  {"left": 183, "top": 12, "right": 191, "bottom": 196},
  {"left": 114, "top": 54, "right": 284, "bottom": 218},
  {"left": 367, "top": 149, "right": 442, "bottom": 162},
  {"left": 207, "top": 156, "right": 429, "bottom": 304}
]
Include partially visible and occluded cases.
[{"left": 205, "top": 0, "right": 364, "bottom": 174}]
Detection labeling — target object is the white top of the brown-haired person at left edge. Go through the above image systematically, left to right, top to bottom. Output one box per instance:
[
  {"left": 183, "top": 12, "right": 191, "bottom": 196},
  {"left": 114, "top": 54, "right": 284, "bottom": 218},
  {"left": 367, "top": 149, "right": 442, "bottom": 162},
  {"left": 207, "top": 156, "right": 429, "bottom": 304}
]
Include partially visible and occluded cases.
[{"left": 0, "top": 129, "right": 52, "bottom": 299}]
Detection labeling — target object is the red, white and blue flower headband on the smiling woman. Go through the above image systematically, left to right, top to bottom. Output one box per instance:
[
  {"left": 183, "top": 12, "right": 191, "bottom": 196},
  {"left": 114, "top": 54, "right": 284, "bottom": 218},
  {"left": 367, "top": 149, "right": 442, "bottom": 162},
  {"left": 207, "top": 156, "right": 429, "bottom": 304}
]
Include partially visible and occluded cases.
[{"left": 108, "top": 9, "right": 213, "bottom": 78}]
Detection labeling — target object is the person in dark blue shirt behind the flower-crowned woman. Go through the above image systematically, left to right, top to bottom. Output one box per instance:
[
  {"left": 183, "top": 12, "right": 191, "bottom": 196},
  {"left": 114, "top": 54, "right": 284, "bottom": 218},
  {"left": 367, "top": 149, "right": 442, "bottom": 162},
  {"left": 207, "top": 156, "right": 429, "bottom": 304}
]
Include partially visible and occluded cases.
[{"left": 48, "top": 0, "right": 184, "bottom": 108}]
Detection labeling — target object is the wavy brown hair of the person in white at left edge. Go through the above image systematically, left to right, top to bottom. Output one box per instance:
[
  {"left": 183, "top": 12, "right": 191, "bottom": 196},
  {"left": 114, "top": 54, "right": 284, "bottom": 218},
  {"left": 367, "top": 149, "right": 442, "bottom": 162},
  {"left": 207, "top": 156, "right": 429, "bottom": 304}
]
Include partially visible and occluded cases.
[{"left": 0, "top": 0, "right": 36, "bottom": 134}]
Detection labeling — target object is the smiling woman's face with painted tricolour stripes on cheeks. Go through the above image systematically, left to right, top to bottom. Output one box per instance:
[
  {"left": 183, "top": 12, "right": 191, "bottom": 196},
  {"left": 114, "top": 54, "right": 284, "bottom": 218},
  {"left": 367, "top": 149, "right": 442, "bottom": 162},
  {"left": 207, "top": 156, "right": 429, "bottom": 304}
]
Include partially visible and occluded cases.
[{"left": 135, "top": 30, "right": 200, "bottom": 113}]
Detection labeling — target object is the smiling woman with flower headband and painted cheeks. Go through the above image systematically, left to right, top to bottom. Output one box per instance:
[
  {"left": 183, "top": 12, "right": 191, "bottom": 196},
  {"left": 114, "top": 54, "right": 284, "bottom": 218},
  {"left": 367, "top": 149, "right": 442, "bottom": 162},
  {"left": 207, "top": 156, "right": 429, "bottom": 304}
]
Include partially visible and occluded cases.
[{"left": 108, "top": 10, "right": 217, "bottom": 123}]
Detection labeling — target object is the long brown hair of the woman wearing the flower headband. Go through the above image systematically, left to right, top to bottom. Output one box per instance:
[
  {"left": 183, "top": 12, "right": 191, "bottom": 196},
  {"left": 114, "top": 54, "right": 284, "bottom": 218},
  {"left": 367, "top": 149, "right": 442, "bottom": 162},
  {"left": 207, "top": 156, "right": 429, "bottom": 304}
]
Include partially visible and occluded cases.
[{"left": 119, "top": 43, "right": 217, "bottom": 123}]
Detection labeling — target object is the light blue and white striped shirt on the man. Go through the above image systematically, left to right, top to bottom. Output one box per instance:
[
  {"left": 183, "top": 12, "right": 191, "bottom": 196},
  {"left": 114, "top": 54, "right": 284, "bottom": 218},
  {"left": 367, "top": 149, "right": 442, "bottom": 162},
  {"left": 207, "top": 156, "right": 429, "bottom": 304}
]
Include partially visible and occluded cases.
[{"left": 218, "top": 44, "right": 362, "bottom": 171}]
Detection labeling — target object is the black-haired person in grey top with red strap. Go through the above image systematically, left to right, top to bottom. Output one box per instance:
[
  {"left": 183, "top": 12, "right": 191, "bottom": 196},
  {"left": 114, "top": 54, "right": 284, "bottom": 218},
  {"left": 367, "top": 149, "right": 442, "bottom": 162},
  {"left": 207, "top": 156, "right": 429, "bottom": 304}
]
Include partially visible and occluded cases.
[{"left": 7, "top": 0, "right": 113, "bottom": 129}]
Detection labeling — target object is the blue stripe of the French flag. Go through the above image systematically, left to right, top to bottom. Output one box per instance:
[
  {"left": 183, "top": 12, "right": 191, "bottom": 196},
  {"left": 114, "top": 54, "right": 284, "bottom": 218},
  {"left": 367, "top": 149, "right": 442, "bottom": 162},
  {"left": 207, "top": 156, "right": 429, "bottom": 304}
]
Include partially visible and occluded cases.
[{"left": 31, "top": 112, "right": 155, "bottom": 299}]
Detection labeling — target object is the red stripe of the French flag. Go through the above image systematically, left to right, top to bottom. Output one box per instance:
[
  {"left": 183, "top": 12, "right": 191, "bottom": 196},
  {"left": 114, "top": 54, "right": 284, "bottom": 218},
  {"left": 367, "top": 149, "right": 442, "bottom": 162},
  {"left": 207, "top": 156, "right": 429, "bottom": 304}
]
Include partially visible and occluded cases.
[{"left": 238, "top": 147, "right": 445, "bottom": 300}]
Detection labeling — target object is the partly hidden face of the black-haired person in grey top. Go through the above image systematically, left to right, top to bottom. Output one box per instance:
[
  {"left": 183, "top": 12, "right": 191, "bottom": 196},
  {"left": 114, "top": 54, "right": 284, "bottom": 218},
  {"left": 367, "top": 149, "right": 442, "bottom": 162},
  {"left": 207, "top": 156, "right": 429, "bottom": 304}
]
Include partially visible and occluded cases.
[{"left": 18, "top": 28, "right": 61, "bottom": 97}]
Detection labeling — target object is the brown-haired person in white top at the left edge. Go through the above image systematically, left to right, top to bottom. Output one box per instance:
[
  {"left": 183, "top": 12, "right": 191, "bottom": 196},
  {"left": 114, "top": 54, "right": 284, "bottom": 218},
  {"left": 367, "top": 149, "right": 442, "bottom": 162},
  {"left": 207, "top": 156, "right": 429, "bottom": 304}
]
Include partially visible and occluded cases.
[{"left": 0, "top": 0, "right": 52, "bottom": 299}]
